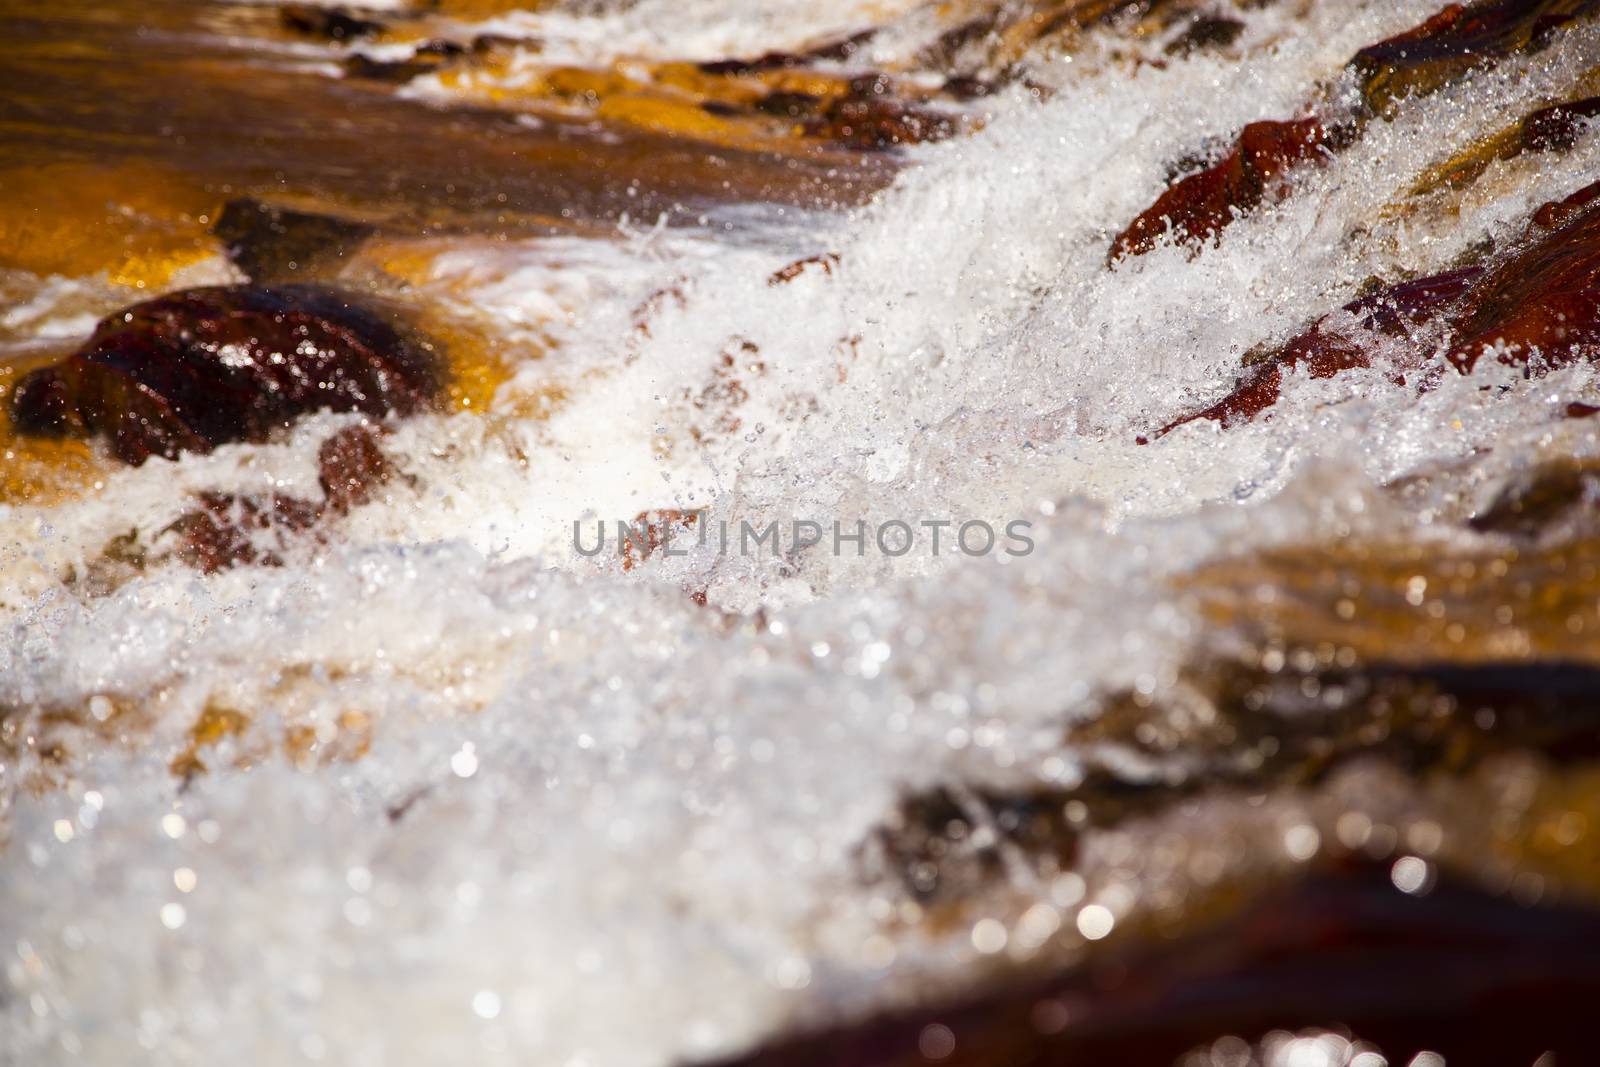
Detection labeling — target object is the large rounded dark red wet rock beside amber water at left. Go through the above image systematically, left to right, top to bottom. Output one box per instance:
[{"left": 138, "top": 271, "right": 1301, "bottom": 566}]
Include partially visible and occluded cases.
[{"left": 11, "top": 285, "right": 440, "bottom": 464}]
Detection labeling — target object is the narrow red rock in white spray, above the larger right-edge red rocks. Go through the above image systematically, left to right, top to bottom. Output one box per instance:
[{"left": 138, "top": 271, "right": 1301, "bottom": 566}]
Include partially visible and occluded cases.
[{"left": 1110, "top": 118, "right": 1328, "bottom": 262}]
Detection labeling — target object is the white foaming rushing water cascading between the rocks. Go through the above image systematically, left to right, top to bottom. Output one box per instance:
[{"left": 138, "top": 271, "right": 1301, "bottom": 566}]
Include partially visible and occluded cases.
[{"left": 0, "top": 0, "right": 1600, "bottom": 1067}]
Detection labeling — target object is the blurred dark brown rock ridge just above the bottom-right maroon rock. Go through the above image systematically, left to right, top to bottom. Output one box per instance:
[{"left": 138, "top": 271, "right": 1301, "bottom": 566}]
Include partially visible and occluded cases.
[{"left": 862, "top": 653, "right": 1600, "bottom": 915}]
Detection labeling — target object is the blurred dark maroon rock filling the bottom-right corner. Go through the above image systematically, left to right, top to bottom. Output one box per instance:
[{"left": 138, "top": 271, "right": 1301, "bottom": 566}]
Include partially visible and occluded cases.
[{"left": 710, "top": 865, "right": 1600, "bottom": 1067}]
